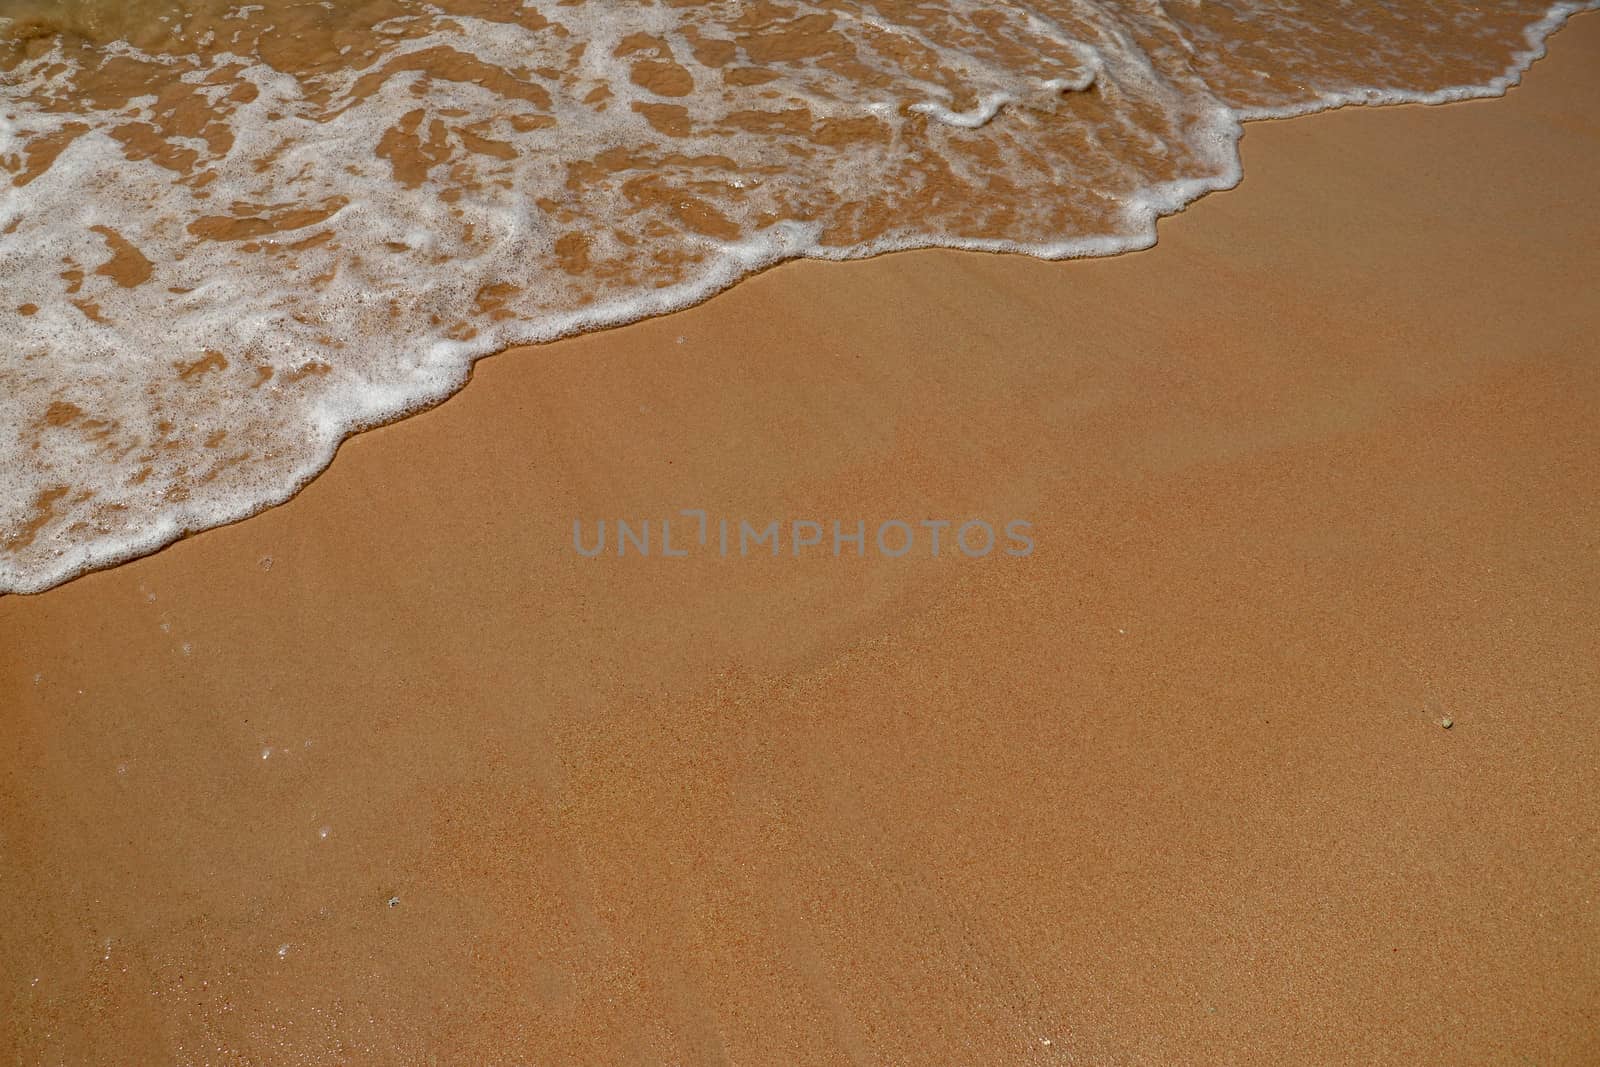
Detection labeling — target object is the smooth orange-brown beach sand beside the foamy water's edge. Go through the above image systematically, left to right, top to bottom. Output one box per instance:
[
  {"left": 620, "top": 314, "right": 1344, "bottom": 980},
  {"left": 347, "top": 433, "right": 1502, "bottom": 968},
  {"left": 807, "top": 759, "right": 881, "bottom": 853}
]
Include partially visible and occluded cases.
[{"left": 0, "top": 18, "right": 1600, "bottom": 1065}]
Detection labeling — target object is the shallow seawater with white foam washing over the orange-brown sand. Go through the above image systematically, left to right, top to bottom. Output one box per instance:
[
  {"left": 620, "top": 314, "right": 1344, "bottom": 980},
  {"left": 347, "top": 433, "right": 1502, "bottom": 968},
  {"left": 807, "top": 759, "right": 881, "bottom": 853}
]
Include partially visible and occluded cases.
[{"left": 0, "top": 0, "right": 1578, "bottom": 592}]
